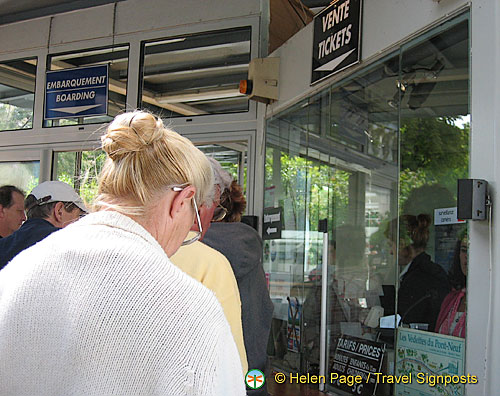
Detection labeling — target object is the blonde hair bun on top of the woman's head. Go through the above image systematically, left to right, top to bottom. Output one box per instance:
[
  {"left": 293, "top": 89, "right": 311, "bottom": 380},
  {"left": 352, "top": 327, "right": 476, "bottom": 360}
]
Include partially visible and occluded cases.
[{"left": 101, "top": 111, "right": 165, "bottom": 161}]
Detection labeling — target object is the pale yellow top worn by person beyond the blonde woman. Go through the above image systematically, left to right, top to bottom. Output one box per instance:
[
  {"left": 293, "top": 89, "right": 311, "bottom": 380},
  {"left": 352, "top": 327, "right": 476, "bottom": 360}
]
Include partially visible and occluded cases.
[{"left": 170, "top": 241, "right": 248, "bottom": 375}]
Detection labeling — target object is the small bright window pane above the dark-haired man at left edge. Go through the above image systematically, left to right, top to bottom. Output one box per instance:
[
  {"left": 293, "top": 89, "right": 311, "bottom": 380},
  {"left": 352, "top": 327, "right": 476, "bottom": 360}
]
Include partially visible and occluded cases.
[{"left": 0, "top": 161, "right": 40, "bottom": 193}]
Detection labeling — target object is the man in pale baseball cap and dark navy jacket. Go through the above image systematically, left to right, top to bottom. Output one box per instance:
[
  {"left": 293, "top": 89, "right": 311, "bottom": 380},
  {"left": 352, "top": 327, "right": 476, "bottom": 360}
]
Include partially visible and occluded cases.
[{"left": 0, "top": 181, "right": 88, "bottom": 270}]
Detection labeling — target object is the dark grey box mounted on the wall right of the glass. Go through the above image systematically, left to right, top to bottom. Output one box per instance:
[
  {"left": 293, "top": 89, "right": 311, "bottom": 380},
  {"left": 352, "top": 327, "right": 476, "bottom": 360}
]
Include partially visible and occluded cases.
[{"left": 457, "top": 179, "right": 488, "bottom": 220}]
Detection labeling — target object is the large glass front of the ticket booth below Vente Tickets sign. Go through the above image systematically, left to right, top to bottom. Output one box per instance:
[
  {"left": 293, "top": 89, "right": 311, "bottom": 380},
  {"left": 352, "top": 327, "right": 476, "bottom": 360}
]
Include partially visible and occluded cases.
[{"left": 263, "top": 15, "right": 470, "bottom": 395}]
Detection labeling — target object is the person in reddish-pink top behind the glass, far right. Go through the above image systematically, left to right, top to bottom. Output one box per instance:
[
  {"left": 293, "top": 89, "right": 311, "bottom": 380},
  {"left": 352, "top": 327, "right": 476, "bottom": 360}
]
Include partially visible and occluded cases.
[{"left": 436, "top": 235, "right": 468, "bottom": 338}]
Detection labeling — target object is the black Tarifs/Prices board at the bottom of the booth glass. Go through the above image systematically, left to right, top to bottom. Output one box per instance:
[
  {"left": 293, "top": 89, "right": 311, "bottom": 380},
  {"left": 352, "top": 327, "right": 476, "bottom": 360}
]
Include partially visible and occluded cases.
[{"left": 330, "top": 335, "right": 385, "bottom": 396}]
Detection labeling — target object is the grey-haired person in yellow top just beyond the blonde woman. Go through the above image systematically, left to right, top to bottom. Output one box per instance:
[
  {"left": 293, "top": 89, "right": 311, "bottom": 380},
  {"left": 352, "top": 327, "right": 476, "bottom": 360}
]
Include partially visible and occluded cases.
[{"left": 170, "top": 157, "right": 248, "bottom": 374}]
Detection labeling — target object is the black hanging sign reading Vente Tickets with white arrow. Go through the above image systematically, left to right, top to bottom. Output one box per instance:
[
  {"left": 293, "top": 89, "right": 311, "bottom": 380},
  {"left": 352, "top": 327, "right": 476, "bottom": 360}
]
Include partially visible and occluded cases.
[{"left": 311, "top": 0, "right": 362, "bottom": 84}]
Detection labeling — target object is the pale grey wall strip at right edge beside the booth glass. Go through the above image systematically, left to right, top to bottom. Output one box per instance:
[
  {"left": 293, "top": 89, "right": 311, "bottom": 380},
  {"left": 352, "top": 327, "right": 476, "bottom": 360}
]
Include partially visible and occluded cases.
[{"left": 467, "top": 0, "right": 500, "bottom": 396}]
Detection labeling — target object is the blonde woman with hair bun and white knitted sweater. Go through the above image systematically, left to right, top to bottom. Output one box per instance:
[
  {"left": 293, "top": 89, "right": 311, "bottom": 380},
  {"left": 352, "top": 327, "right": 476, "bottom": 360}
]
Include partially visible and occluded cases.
[{"left": 0, "top": 111, "right": 245, "bottom": 396}]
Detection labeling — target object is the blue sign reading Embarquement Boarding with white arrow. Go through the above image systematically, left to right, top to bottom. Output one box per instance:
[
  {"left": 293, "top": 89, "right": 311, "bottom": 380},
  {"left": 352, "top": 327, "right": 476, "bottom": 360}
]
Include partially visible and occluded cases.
[{"left": 45, "top": 65, "right": 108, "bottom": 120}]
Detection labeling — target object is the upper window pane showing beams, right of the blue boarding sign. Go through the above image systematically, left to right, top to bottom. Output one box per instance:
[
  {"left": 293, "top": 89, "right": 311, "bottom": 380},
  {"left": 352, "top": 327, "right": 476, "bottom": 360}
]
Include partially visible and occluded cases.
[{"left": 139, "top": 27, "right": 251, "bottom": 118}]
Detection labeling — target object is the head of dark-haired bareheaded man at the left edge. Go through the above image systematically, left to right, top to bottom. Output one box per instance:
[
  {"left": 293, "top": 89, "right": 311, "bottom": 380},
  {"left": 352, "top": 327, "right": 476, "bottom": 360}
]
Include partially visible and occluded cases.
[{"left": 0, "top": 186, "right": 26, "bottom": 239}]
